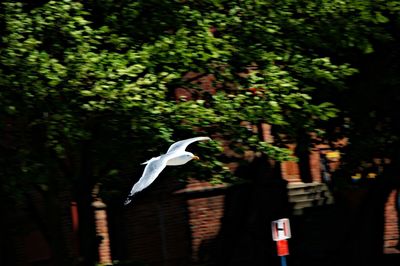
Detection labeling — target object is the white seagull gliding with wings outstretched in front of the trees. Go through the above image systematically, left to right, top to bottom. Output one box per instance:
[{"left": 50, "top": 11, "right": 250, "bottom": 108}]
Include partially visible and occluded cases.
[{"left": 124, "top": 137, "right": 211, "bottom": 205}]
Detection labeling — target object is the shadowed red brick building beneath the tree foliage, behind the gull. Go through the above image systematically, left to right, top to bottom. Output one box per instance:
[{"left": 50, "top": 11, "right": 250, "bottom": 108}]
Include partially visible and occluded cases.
[{"left": 1, "top": 143, "right": 399, "bottom": 266}]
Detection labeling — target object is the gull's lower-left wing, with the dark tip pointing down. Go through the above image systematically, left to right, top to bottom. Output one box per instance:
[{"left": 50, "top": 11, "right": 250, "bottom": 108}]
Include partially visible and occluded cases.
[{"left": 124, "top": 155, "right": 170, "bottom": 205}]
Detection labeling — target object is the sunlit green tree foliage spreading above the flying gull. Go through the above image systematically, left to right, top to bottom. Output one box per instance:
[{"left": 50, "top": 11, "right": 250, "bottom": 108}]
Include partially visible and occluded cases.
[{"left": 0, "top": 0, "right": 399, "bottom": 262}]
